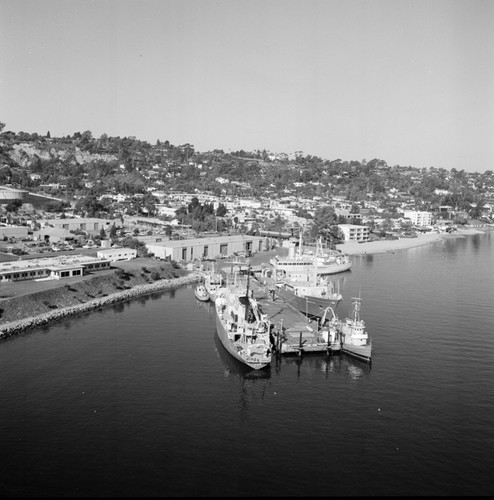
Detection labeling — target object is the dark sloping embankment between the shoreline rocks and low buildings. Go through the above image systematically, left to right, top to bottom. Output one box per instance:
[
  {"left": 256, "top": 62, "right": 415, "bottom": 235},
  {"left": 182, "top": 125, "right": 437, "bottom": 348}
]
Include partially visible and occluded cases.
[{"left": 0, "top": 258, "right": 189, "bottom": 326}]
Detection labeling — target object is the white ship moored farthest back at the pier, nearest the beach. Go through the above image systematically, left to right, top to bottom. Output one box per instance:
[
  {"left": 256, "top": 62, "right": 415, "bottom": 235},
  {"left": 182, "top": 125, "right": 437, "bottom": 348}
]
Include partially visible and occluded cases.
[{"left": 270, "top": 234, "right": 352, "bottom": 275}]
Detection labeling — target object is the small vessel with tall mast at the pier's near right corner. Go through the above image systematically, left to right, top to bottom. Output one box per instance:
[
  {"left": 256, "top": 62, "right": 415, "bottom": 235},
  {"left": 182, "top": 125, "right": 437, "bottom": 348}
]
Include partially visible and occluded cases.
[{"left": 340, "top": 297, "right": 372, "bottom": 361}]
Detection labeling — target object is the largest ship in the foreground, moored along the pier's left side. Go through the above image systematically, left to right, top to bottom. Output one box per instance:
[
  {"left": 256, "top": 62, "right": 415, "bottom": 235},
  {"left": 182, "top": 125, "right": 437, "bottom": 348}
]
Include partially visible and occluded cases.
[{"left": 215, "top": 273, "right": 272, "bottom": 370}]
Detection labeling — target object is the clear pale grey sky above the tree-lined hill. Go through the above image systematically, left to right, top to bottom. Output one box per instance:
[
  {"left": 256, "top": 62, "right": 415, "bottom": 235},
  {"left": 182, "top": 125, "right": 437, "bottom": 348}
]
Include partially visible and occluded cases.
[{"left": 0, "top": 0, "right": 494, "bottom": 172}]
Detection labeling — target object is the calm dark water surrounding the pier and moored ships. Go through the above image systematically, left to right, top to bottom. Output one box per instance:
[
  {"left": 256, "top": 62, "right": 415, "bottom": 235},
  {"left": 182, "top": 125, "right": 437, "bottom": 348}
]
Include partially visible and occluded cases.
[{"left": 0, "top": 233, "right": 494, "bottom": 497}]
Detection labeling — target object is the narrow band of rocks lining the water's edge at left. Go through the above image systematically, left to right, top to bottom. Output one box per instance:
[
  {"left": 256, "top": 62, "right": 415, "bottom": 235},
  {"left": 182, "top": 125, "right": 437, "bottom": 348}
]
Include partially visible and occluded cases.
[{"left": 0, "top": 272, "right": 202, "bottom": 339}]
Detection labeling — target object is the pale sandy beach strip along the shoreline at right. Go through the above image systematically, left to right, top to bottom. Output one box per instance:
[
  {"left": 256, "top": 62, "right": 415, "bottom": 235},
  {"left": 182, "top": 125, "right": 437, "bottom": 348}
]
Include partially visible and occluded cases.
[{"left": 336, "top": 229, "right": 485, "bottom": 255}]
